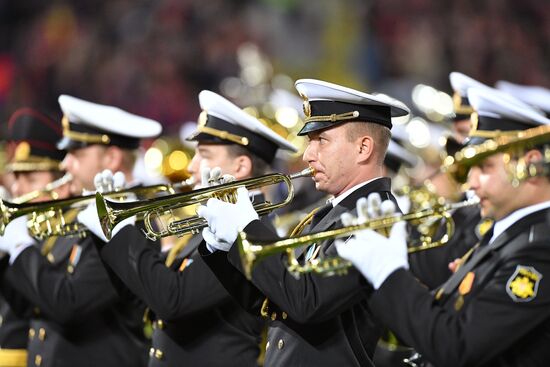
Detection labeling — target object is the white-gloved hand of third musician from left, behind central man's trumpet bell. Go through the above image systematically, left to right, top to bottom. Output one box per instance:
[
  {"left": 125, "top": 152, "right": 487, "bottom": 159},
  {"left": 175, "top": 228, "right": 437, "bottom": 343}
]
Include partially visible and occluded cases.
[{"left": 77, "top": 170, "right": 136, "bottom": 242}]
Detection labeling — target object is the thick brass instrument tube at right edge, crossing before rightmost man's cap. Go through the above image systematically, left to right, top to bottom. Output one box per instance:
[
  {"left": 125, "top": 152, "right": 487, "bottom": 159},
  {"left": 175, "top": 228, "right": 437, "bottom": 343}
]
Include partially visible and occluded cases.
[{"left": 441, "top": 125, "right": 550, "bottom": 186}]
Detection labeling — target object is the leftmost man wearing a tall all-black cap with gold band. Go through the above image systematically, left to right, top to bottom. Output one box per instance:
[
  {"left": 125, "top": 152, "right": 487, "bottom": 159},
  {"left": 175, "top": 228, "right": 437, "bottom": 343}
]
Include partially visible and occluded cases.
[{"left": 0, "top": 108, "right": 69, "bottom": 366}]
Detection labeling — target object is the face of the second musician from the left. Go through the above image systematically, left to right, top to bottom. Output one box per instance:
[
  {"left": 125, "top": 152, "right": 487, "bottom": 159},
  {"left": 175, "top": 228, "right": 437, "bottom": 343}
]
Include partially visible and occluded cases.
[{"left": 62, "top": 145, "right": 105, "bottom": 195}]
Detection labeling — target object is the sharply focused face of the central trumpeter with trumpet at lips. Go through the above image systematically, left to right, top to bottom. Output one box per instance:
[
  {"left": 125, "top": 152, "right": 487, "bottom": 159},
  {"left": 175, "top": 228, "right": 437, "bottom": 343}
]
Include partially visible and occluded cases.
[{"left": 303, "top": 125, "right": 357, "bottom": 196}]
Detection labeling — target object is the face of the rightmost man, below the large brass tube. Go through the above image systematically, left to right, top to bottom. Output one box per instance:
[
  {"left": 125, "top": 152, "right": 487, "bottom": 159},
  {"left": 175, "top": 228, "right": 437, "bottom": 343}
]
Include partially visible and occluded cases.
[{"left": 468, "top": 153, "right": 524, "bottom": 220}]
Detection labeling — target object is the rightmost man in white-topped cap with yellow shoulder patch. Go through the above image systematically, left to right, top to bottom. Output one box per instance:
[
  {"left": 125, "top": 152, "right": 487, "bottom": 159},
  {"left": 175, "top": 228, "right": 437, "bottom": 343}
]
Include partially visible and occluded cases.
[{"left": 338, "top": 89, "right": 550, "bottom": 366}]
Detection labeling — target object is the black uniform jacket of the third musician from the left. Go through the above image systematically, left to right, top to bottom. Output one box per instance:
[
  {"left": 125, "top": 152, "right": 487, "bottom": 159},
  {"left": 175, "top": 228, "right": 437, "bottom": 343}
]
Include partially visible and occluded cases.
[{"left": 101, "top": 216, "right": 265, "bottom": 367}]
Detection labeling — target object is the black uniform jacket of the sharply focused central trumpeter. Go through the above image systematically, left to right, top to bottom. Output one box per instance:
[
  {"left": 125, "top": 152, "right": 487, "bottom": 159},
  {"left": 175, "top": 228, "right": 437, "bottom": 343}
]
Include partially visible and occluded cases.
[{"left": 200, "top": 178, "right": 395, "bottom": 366}]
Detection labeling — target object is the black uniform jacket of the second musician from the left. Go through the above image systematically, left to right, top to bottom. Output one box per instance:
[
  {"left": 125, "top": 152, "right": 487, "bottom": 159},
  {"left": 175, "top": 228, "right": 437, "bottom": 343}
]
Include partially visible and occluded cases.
[{"left": 2, "top": 236, "right": 147, "bottom": 367}]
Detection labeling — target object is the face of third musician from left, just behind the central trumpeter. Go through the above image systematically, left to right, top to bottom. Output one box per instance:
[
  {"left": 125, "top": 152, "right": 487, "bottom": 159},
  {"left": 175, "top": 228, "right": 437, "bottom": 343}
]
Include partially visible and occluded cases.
[{"left": 187, "top": 143, "right": 240, "bottom": 184}]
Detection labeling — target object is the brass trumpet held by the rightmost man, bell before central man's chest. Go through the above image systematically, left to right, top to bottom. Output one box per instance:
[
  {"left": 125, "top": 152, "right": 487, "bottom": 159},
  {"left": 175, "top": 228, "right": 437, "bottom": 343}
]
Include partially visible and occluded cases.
[{"left": 237, "top": 197, "right": 479, "bottom": 279}]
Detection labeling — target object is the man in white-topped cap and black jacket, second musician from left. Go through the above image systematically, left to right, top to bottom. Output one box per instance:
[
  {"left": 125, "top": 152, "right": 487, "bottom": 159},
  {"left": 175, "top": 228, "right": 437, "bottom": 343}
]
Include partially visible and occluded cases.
[{"left": 0, "top": 96, "right": 161, "bottom": 366}]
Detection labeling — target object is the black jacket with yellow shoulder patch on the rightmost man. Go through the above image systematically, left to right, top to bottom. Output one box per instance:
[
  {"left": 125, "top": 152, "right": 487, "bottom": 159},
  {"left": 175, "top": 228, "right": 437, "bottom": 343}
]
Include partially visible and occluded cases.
[{"left": 370, "top": 209, "right": 550, "bottom": 366}]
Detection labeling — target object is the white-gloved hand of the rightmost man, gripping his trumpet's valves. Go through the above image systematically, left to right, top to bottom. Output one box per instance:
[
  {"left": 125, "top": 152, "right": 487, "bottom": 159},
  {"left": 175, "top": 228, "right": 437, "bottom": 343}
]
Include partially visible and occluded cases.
[{"left": 335, "top": 195, "right": 409, "bottom": 289}]
